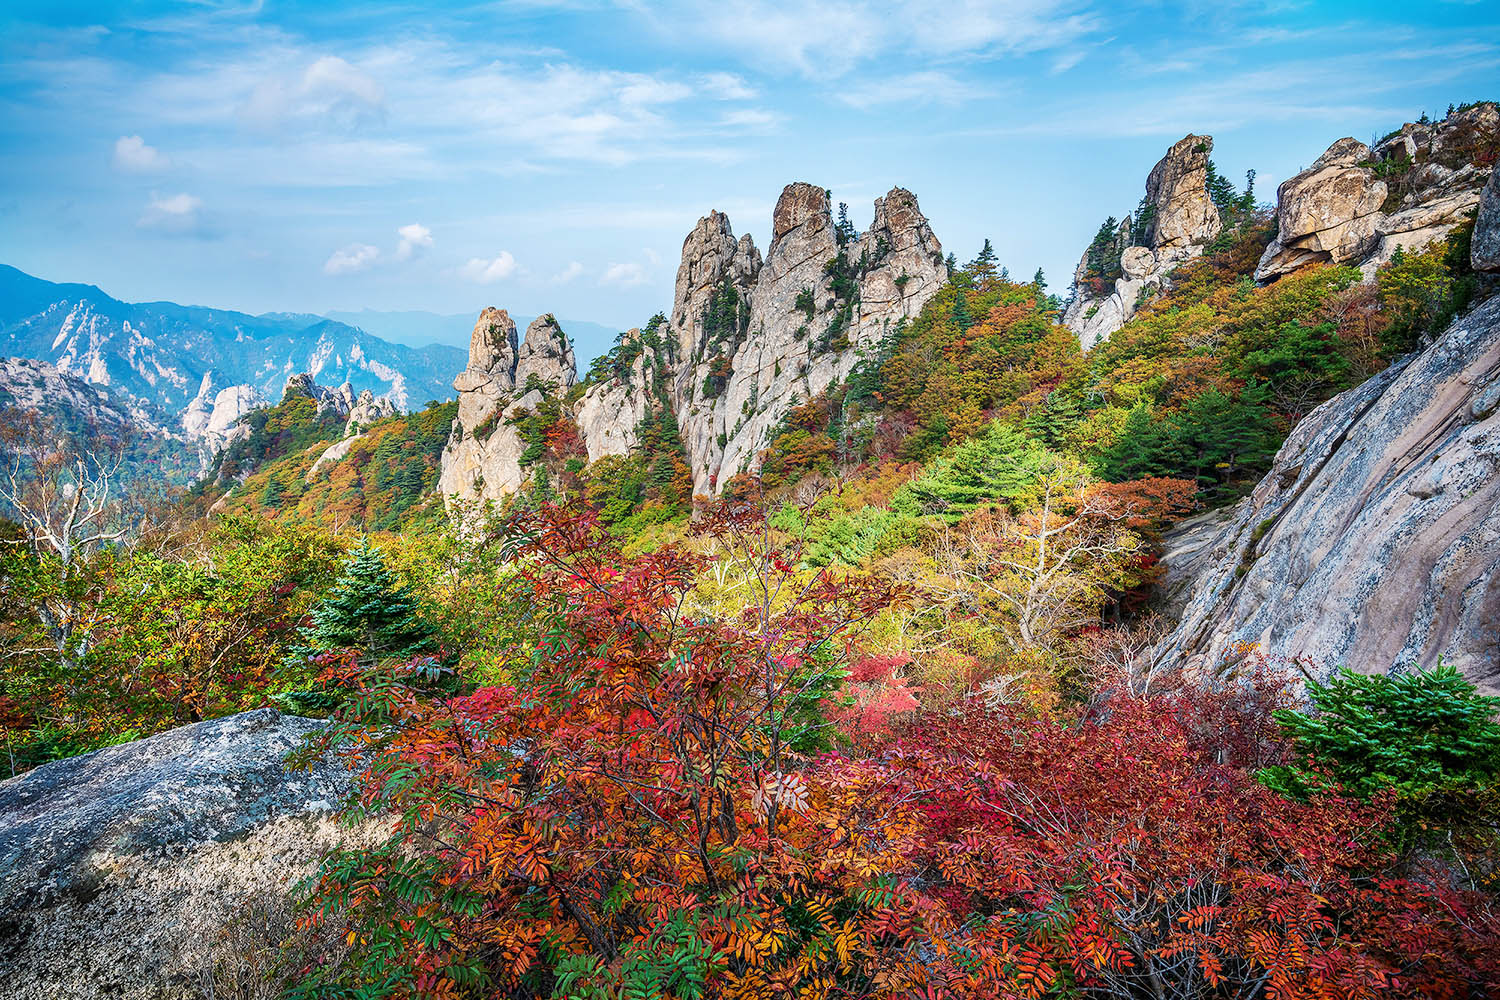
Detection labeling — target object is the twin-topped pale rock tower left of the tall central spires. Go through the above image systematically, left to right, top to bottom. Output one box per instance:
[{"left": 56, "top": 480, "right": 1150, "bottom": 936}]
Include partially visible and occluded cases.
[{"left": 438, "top": 306, "right": 578, "bottom": 499}]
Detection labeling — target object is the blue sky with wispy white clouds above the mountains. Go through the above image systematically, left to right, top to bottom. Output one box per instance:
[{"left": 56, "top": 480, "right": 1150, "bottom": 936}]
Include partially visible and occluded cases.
[{"left": 0, "top": 0, "right": 1500, "bottom": 347}]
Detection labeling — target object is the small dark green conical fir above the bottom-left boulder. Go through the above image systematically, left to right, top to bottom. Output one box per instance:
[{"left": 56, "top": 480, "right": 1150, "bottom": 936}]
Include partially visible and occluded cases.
[{"left": 296, "top": 538, "right": 437, "bottom": 661}]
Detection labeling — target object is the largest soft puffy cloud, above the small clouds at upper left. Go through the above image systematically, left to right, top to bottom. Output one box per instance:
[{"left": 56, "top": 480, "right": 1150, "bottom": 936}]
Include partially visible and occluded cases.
[{"left": 242, "top": 55, "right": 386, "bottom": 130}]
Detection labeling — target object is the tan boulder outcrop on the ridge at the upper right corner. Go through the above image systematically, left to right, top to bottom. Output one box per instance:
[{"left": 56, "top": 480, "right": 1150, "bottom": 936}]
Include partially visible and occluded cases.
[{"left": 1256, "top": 103, "right": 1500, "bottom": 282}]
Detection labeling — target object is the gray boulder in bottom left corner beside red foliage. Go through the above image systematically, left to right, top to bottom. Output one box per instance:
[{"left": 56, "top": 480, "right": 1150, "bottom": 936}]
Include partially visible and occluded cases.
[{"left": 0, "top": 709, "right": 363, "bottom": 1000}]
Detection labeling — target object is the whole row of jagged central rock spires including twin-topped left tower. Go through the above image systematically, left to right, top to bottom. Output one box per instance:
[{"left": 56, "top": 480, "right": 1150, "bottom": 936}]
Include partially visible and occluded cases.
[{"left": 440, "top": 183, "right": 948, "bottom": 498}]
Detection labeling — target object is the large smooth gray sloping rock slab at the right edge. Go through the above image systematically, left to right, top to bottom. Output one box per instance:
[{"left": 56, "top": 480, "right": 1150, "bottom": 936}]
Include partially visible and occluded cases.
[{"left": 1155, "top": 297, "right": 1500, "bottom": 693}]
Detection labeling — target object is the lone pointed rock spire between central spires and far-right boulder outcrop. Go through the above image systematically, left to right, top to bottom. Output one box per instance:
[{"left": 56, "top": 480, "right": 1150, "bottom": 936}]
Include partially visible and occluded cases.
[{"left": 1062, "top": 135, "right": 1223, "bottom": 349}]
